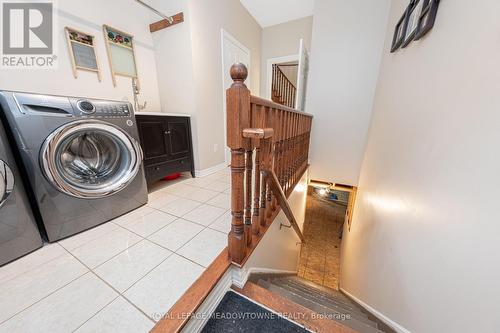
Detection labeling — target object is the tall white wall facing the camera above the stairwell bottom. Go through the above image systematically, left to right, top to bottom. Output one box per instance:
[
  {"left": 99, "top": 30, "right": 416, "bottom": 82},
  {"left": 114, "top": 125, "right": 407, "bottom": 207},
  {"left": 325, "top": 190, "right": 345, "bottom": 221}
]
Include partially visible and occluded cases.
[{"left": 305, "top": 0, "right": 390, "bottom": 185}]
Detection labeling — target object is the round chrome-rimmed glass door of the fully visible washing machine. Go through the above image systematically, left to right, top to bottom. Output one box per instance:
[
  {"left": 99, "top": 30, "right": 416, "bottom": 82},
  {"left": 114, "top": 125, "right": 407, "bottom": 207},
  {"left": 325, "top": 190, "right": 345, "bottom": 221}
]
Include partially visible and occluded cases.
[{"left": 40, "top": 121, "right": 142, "bottom": 199}]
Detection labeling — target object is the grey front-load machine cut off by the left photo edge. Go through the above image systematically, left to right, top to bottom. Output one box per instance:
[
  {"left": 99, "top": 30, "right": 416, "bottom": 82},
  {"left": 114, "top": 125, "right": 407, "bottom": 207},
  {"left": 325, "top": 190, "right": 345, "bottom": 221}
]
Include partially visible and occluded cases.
[{"left": 0, "top": 110, "right": 42, "bottom": 266}]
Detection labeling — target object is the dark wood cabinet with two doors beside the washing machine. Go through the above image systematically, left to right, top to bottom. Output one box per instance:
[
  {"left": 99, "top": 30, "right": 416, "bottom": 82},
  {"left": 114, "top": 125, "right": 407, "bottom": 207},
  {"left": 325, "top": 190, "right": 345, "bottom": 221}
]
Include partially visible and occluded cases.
[{"left": 136, "top": 114, "right": 194, "bottom": 185}]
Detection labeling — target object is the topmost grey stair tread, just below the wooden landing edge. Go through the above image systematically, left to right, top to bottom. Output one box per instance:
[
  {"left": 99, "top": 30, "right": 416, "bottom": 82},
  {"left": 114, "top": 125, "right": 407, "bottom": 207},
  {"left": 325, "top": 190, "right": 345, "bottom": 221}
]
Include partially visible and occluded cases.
[{"left": 258, "top": 280, "right": 377, "bottom": 332}]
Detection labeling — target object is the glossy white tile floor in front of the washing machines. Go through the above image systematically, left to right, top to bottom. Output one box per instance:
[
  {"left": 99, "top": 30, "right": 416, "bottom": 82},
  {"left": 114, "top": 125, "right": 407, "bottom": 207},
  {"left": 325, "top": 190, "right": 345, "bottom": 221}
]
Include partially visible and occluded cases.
[{"left": 0, "top": 170, "right": 231, "bottom": 333}]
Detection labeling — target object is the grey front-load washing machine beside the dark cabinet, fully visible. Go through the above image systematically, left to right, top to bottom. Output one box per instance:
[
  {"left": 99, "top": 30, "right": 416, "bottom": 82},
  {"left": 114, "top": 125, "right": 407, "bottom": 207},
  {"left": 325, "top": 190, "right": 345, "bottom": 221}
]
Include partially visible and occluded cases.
[{"left": 0, "top": 91, "right": 147, "bottom": 242}]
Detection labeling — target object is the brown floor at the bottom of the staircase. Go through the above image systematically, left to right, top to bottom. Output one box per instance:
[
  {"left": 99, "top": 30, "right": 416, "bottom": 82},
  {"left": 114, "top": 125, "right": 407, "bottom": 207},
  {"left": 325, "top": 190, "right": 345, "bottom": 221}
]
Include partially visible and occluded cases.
[{"left": 297, "top": 190, "right": 345, "bottom": 290}]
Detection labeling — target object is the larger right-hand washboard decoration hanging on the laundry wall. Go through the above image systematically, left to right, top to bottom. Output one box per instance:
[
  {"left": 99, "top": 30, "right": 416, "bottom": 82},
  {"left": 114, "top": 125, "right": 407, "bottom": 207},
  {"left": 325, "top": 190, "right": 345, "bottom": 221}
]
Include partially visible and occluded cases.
[{"left": 103, "top": 25, "right": 139, "bottom": 87}]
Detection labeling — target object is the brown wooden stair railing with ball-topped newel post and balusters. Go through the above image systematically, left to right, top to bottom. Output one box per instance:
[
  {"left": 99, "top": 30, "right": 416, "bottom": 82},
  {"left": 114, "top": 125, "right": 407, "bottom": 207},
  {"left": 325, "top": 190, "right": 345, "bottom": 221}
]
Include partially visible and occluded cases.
[{"left": 226, "top": 64, "right": 312, "bottom": 265}]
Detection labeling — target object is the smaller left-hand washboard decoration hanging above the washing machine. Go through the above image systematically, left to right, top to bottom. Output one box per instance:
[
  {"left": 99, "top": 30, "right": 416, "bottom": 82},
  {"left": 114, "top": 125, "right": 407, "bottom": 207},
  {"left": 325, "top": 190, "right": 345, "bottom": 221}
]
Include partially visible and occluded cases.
[{"left": 64, "top": 27, "right": 102, "bottom": 82}]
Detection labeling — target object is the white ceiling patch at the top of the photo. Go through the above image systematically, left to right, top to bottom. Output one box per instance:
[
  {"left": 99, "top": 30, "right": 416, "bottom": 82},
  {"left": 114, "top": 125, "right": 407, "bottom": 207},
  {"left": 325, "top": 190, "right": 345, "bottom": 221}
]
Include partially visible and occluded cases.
[{"left": 240, "top": 0, "right": 314, "bottom": 28}]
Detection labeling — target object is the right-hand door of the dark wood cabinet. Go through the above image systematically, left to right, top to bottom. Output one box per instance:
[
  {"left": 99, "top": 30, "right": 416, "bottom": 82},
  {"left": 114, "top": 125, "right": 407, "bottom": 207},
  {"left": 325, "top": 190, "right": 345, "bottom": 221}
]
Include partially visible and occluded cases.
[{"left": 165, "top": 117, "right": 191, "bottom": 160}]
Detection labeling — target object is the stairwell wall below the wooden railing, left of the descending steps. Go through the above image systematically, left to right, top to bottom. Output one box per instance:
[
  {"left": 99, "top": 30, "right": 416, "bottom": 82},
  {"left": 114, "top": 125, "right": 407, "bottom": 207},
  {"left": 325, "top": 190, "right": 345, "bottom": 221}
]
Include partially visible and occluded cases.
[{"left": 244, "top": 172, "right": 309, "bottom": 272}]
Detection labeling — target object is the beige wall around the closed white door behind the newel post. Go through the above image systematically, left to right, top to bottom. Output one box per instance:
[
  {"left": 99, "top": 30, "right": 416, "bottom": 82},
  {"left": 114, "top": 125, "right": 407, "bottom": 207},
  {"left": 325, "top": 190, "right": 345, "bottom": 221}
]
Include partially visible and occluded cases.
[{"left": 190, "top": 0, "right": 261, "bottom": 169}]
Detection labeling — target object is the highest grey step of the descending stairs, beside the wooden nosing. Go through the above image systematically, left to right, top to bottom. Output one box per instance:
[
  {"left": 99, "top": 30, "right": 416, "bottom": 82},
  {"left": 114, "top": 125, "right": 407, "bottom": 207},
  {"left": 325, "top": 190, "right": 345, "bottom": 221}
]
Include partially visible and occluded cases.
[{"left": 259, "top": 280, "right": 382, "bottom": 333}]
